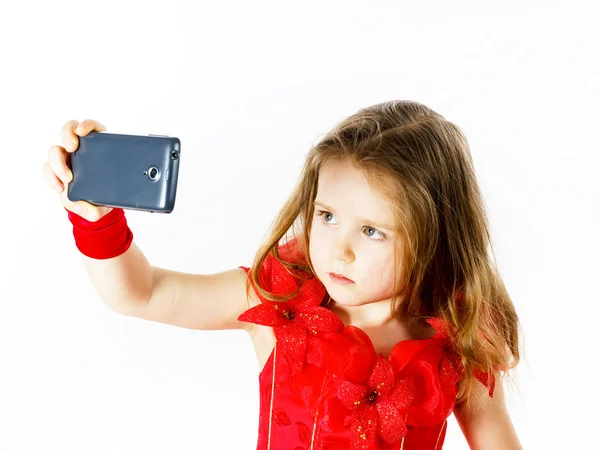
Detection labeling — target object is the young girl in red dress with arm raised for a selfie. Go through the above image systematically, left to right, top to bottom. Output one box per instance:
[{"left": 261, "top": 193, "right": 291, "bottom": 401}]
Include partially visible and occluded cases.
[{"left": 44, "top": 101, "right": 521, "bottom": 450}]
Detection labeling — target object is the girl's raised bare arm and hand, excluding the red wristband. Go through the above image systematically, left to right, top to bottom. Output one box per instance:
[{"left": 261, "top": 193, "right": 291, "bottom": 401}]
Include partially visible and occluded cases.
[{"left": 43, "top": 120, "right": 258, "bottom": 330}]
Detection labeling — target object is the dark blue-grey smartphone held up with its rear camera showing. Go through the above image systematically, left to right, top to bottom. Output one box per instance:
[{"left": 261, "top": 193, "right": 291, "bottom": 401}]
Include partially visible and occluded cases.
[{"left": 67, "top": 131, "right": 181, "bottom": 213}]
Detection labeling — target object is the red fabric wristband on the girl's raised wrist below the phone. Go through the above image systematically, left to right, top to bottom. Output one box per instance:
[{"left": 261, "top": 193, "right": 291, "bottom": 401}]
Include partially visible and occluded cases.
[{"left": 67, "top": 208, "right": 133, "bottom": 259}]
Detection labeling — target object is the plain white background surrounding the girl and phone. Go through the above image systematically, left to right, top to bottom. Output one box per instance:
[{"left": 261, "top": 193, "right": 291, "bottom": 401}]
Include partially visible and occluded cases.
[{"left": 0, "top": 0, "right": 600, "bottom": 450}]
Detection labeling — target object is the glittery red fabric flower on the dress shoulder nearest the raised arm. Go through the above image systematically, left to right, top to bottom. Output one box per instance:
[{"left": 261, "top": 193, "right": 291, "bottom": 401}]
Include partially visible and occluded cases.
[{"left": 238, "top": 255, "right": 344, "bottom": 371}]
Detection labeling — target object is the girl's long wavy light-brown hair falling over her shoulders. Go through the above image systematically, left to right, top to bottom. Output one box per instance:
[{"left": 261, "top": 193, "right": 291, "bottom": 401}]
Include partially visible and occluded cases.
[{"left": 247, "top": 100, "right": 520, "bottom": 403}]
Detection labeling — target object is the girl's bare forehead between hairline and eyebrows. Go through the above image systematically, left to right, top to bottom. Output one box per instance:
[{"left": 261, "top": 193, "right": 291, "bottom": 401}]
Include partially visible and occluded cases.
[{"left": 316, "top": 160, "right": 394, "bottom": 224}]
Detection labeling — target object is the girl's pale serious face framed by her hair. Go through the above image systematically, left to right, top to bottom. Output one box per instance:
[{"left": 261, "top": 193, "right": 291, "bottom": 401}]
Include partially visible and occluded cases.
[{"left": 309, "top": 161, "right": 398, "bottom": 306}]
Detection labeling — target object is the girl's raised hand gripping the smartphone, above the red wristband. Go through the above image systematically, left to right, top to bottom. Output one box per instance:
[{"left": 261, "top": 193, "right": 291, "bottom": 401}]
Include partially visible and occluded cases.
[{"left": 43, "top": 120, "right": 112, "bottom": 222}]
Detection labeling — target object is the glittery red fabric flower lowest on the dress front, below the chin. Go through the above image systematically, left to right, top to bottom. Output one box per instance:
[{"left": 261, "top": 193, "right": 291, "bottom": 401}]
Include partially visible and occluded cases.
[{"left": 336, "top": 355, "right": 416, "bottom": 450}]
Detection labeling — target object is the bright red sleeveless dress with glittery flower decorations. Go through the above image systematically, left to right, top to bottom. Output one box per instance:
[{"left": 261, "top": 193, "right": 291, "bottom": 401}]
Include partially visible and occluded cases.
[{"left": 239, "top": 246, "right": 494, "bottom": 450}]
